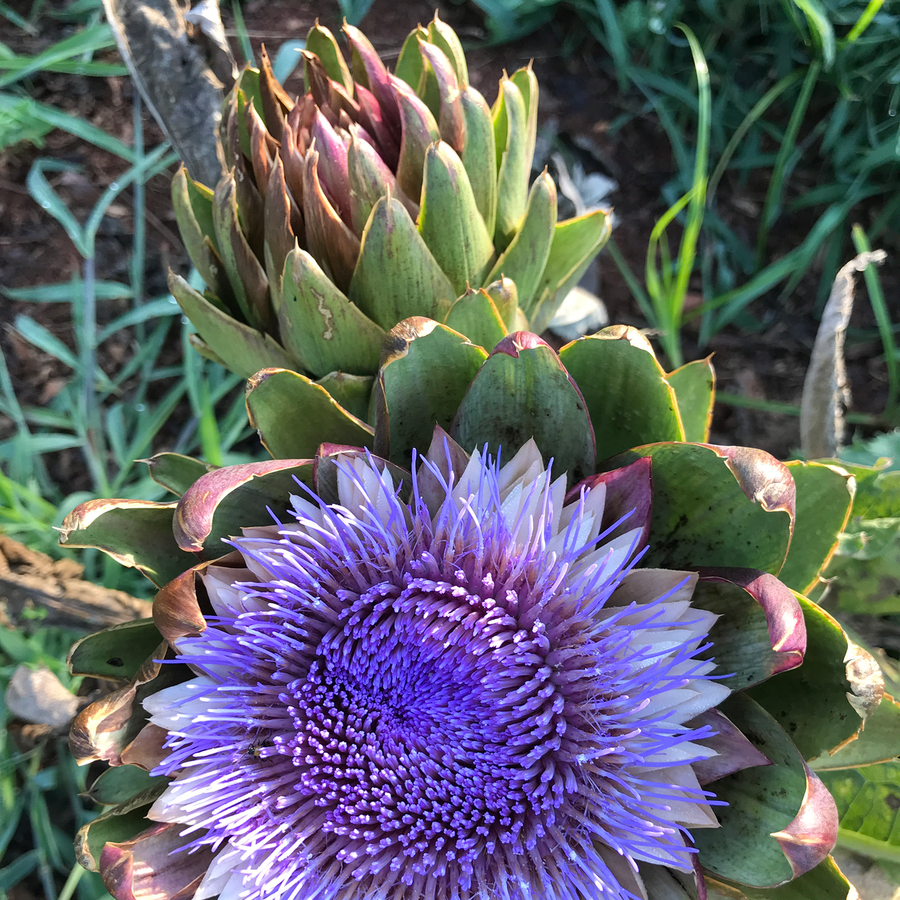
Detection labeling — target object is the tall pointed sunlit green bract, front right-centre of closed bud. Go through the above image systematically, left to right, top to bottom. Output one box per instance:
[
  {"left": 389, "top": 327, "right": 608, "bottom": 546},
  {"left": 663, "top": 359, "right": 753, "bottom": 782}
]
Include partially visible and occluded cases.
[{"left": 418, "top": 141, "right": 494, "bottom": 294}]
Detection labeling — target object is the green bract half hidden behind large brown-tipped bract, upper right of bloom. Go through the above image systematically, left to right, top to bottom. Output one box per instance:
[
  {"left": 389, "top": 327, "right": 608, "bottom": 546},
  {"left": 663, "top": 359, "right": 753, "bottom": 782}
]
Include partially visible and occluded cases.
[{"left": 779, "top": 460, "right": 854, "bottom": 593}]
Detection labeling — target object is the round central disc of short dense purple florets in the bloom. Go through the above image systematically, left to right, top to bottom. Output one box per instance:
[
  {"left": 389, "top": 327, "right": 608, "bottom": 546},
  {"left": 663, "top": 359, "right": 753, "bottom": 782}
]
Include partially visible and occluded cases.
[{"left": 273, "top": 565, "right": 568, "bottom": 889}]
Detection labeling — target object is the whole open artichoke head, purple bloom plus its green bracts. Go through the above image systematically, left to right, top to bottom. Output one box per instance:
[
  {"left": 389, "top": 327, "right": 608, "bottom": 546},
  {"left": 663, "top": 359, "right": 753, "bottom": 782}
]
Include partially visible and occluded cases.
[{"left": 63, "top": 328, "right": 900, "bottom": 900}]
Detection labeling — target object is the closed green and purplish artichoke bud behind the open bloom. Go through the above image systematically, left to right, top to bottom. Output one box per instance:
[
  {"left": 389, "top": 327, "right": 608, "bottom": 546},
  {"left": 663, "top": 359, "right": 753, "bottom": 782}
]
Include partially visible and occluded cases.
[{"left": 170, "top": 16, "right": 609, "bottom": 389}]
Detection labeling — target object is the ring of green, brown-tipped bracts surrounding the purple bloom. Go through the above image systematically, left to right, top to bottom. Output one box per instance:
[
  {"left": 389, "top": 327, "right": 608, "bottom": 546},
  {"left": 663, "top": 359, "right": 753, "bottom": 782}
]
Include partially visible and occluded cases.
[{"left": 62, "top": 324, "right": 888, "bottom": 900}]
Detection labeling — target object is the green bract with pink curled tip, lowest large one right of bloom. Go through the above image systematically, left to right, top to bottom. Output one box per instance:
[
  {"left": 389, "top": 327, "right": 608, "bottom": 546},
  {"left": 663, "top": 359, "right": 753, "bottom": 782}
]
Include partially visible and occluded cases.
[{"left": 692, "top": 694, "right": 836, "bottom": 888}]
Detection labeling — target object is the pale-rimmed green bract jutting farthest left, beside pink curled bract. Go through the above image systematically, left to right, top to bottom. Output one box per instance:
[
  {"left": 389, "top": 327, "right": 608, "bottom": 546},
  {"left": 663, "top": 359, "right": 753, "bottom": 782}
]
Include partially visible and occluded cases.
[{"left": 59, "top": 500, "right": 197, "bottom": 587}]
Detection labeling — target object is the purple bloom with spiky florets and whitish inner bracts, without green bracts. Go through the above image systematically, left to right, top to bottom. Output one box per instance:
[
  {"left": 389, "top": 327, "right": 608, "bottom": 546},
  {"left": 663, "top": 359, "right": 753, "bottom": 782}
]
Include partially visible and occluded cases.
[{"left": 144, "top": 442, "right": 729, "bottom": 900}]
